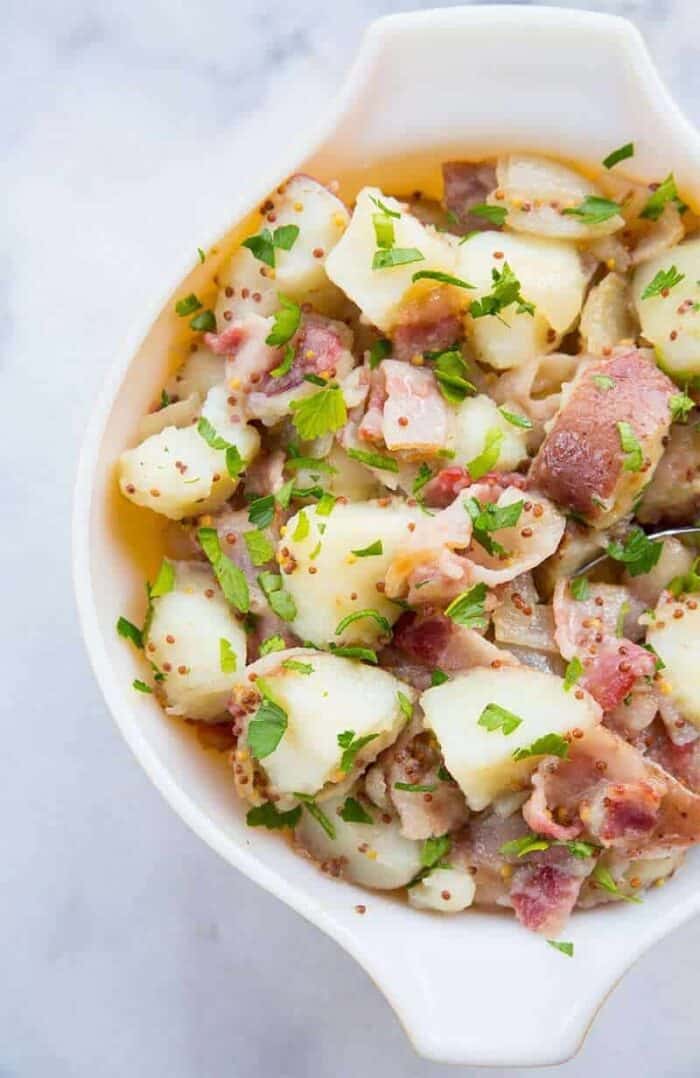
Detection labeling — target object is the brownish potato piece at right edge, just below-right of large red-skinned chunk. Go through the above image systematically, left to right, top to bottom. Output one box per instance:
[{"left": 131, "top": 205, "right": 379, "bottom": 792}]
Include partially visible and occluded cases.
[{"left": 636, "top": 412, "right": 700, "bottom": 524}]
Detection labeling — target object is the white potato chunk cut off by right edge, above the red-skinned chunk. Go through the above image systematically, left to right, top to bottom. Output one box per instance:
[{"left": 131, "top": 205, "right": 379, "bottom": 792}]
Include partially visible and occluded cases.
[{"left": 632, "top": 239, "right": 700, "bottom": 383}]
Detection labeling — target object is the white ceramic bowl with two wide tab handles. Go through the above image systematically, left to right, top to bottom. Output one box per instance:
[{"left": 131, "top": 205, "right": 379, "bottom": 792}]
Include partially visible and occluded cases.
[{"left": 73, "top": 6, "right": 700, "bottom": 1065}]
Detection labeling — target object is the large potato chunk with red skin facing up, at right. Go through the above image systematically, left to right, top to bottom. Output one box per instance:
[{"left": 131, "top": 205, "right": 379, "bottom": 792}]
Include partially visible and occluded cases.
[{"left": 530, "top": 348, "right": 675, "bottom": 527}]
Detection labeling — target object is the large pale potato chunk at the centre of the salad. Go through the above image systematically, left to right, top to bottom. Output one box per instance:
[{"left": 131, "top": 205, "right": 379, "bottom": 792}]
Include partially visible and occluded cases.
[{"left": 278, "top": 501, "right": 422, "bottom": 647}]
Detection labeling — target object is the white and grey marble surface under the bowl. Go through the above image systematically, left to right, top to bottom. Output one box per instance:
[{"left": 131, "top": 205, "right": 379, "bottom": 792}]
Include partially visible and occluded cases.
[{"left": 5, "top": 0, "right": 700, "bottom": 1078}]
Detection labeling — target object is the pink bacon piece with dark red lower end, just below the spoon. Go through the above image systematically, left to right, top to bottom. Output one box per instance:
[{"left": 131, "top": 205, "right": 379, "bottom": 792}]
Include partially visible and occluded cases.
[{"left": 553, "top": 580, "right": 656, "bottom": 711}]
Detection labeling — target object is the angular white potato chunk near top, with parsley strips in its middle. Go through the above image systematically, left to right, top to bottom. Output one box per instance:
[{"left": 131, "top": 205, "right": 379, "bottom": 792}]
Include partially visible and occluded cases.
[{"left": 326, "top": 188, "right": 456, "bottom": 331}]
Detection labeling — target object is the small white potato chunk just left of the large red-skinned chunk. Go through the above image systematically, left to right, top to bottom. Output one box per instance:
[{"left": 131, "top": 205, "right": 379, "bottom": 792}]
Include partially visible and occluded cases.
[{"left": 450, "top": 393, "right": 527, "bottom": 471}]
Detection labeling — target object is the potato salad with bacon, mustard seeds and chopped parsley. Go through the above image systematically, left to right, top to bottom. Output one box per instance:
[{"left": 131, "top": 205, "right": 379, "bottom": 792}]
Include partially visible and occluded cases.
[{"left": 118, "top": 154, "right": 700, "bottom": 955}]
